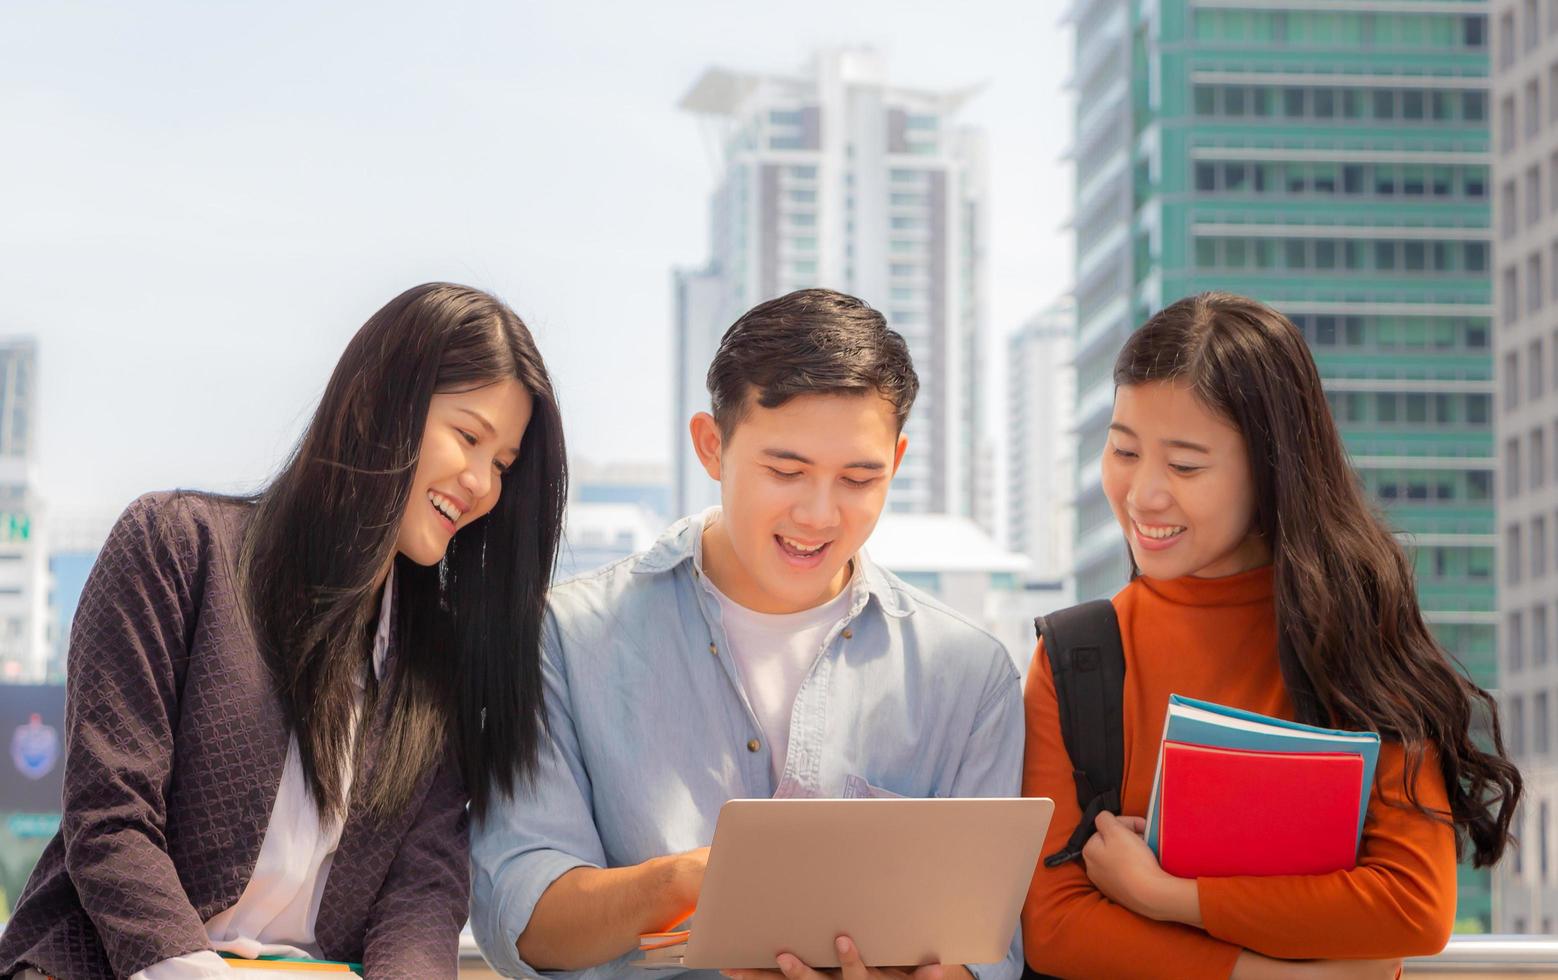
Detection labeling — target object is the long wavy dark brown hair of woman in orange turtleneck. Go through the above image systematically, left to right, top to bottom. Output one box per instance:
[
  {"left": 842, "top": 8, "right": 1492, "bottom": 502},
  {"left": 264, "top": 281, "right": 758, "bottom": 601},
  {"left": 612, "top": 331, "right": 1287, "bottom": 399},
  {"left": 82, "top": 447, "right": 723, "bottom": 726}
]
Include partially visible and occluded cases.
[{"left": 1114, "top": 293, "right": 1521, "bottom": 868}]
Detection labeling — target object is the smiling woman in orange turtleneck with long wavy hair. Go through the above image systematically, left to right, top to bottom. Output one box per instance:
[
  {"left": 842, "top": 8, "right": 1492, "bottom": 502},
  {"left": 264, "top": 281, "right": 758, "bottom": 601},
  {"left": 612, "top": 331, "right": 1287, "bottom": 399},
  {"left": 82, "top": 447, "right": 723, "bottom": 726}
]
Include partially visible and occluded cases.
[{"left": 1022, "top": 293, "right": 1521, "bottom": 980}]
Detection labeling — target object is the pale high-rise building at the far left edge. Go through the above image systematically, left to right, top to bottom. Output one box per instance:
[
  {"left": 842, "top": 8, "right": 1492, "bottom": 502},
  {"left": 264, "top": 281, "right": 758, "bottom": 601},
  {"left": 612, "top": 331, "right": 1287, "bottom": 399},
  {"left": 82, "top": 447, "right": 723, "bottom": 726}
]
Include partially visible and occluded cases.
[{"left": 0, "top": 338, "right": 50, "bottom": 681}]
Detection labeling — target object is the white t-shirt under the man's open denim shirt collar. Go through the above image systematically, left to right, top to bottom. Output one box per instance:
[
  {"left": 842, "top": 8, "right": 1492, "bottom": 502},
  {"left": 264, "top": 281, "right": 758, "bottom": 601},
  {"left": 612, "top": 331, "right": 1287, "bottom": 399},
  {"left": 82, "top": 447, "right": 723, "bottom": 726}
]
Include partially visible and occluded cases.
[{"left": 703, "top": 575, "right": 851, "bottom": 782}]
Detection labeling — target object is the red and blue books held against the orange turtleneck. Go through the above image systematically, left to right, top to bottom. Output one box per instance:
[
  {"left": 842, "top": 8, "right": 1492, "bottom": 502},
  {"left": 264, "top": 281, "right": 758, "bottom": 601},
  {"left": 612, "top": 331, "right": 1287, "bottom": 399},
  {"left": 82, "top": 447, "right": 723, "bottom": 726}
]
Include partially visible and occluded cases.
[{"left": 1147, "top": 695, "right": 1379, "bottom": 877}]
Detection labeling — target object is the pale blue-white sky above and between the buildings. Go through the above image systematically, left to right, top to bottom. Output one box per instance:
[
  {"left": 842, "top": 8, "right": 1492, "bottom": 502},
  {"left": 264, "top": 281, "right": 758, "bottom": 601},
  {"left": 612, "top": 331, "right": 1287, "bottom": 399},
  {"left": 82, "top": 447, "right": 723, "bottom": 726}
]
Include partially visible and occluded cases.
[{"left": 0, "top": 0, "right": 1070, "bottom": 516}]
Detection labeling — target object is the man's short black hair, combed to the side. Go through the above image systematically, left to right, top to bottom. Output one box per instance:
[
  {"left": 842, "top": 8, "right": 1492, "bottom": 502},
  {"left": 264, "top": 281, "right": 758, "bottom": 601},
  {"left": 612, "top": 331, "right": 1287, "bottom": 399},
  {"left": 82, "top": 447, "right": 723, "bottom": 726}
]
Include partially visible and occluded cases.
[{"left": 707, "top": 283, "right": 919, "bottom": 439}]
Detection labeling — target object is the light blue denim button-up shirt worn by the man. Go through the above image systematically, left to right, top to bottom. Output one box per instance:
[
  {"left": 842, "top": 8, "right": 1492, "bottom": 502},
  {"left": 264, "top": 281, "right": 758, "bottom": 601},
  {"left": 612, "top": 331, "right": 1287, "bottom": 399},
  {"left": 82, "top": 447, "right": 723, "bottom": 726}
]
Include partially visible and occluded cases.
[{"left": 471, "top": 511, "right": 1024, "bottom": 980}]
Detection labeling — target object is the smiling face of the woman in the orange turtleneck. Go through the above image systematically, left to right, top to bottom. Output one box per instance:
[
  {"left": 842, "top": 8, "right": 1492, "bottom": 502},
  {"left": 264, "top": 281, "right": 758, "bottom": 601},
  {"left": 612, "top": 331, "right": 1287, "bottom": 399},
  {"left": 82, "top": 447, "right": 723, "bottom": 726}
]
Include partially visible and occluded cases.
[{"left": 1103, "top": 382, "right": 1271, "bottom": 578}]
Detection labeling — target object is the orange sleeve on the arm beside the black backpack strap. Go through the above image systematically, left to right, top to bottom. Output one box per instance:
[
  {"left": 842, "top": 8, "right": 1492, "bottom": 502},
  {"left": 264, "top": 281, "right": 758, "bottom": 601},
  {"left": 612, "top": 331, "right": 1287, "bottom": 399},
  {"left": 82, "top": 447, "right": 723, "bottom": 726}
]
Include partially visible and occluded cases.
[{"left": 1022, "top": 643, "right": 1240, "bottom": 980}]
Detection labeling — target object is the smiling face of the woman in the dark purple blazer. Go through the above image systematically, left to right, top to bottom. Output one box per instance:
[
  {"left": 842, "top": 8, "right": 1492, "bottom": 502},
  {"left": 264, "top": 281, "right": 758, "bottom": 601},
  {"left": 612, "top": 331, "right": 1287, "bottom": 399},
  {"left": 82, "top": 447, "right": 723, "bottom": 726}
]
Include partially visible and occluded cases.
[{"left": 396, "top": 379, "right": 531, "bottom": 566}]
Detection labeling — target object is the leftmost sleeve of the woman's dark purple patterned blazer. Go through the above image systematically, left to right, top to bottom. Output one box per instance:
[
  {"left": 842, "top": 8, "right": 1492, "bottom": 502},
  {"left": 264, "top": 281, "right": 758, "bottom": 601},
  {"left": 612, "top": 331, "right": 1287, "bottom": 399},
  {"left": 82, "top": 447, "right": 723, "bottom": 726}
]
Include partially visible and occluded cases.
[{"left": 61, "top": 497, "right": 209, "bottom": 977}]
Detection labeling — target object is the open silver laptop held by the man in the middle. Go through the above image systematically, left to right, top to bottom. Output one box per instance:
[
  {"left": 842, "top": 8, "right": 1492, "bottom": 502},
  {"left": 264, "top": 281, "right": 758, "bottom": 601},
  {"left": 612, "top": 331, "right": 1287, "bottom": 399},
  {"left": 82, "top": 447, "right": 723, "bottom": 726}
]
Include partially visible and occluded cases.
[{"left": 640, "top": 799, "right": 1055, "bottom": 969}]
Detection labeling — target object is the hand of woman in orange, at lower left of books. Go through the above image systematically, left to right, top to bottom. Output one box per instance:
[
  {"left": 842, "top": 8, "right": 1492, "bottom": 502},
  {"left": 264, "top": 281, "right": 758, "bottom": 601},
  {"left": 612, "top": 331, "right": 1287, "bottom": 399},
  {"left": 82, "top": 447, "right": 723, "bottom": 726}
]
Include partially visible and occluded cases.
[{"left": 1081, "top": 813, "right": 1201, "bottom": 927}]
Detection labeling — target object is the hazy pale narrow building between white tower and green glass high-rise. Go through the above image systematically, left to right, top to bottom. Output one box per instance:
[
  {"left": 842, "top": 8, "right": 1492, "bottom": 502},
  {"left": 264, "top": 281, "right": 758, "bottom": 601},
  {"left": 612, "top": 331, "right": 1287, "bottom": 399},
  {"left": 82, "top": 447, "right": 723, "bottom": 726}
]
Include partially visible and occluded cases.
[{"left": 1006, "top": 298, "right": 1077, "bottom": 581}]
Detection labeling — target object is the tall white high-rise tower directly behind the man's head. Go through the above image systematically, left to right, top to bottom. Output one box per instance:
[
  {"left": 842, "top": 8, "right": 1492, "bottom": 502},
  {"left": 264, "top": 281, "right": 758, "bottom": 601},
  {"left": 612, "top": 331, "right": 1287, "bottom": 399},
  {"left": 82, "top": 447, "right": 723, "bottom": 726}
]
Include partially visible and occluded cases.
[{"left": 673, "top": 50, "right": 992, "bottom": 525}]
